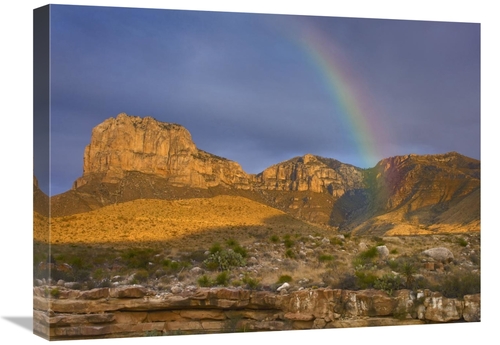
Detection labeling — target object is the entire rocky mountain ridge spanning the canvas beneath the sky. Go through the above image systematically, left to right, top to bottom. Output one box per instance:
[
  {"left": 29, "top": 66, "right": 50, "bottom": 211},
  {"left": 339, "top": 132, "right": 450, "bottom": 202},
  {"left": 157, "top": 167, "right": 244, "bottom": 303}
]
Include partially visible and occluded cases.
[{"left": 44, "top": 113, "right": 480, "bottom": 234}]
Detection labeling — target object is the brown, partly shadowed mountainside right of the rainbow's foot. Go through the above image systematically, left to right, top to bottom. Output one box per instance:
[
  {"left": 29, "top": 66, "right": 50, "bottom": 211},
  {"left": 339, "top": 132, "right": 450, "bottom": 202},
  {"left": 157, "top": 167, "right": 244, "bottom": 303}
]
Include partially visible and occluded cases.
[{"left": 339, "top": 152, "right": 480, "bottom": 235}]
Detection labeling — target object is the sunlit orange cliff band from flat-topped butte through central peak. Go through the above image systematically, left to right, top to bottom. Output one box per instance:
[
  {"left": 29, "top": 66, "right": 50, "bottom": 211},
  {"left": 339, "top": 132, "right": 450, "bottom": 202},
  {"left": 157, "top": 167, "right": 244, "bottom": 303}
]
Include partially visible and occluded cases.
[{"left": 74, "top": 113, "right": 363, "bottom": 197}]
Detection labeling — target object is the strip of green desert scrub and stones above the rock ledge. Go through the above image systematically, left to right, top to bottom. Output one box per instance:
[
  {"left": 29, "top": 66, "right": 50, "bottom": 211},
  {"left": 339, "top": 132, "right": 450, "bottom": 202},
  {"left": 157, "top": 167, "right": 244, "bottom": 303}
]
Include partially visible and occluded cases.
[{"left": 33, "top": 223, "right": 480, "bottom": 298}]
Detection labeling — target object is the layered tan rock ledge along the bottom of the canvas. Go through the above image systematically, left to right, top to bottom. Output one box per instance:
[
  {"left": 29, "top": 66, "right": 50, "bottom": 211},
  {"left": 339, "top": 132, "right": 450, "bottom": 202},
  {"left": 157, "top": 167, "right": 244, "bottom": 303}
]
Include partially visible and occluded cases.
[{"left": 33, "top": 286, "right": 481, "bottom": 340}]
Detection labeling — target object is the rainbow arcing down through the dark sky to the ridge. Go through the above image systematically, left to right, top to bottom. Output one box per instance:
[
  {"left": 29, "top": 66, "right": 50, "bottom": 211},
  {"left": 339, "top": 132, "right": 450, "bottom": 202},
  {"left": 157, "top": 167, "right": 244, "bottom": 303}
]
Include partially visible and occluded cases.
[{"left": 286, "top": 18, "right": 385, "bottom": 167}]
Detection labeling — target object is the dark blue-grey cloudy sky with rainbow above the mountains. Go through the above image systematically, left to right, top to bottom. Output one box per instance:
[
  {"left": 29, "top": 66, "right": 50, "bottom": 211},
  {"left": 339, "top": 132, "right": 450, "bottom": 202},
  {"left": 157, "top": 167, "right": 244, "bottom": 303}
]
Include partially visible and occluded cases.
[{"left": 35, "top": 6, "right": 480, "bottom": 195}]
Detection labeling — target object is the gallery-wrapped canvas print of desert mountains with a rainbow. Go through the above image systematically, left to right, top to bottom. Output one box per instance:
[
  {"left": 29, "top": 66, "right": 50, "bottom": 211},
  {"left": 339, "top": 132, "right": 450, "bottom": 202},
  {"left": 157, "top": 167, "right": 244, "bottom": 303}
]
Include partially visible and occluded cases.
[{"left": 33, "top": 5, "right": 481, "bottom": 340}]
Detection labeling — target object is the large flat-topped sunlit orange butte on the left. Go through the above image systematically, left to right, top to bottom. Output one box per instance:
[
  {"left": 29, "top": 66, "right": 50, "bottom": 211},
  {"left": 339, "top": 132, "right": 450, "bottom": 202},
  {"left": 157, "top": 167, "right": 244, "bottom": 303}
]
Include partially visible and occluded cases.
[{"left": 74, "top": 113, "right": 254, "bottom": 189}]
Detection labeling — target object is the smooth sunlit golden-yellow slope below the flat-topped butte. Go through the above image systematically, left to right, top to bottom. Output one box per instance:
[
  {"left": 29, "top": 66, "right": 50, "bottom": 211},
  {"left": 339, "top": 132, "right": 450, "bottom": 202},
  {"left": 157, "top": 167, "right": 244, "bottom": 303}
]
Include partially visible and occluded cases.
[{"left": 35, "top": 196, "right": 330, "bottom": 246}]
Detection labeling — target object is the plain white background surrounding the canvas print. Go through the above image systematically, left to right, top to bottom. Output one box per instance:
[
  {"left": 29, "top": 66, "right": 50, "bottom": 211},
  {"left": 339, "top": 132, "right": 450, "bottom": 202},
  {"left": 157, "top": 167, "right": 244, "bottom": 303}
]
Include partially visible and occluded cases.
[{"left": 0, "top": 0, "right": 494, "bottom": 345}]
